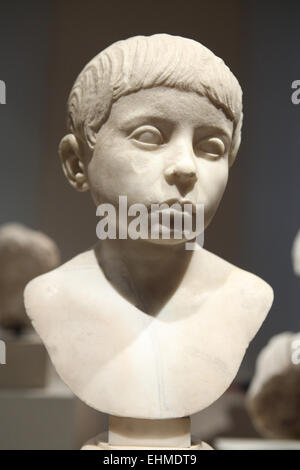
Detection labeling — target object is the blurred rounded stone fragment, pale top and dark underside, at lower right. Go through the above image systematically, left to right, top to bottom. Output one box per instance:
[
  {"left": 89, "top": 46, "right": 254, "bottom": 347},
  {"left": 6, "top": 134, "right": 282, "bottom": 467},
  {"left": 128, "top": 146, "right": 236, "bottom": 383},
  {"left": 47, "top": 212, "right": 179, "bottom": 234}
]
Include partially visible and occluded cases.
[{"left": 247, "top": 332, "right": 300, "bottom": 439}]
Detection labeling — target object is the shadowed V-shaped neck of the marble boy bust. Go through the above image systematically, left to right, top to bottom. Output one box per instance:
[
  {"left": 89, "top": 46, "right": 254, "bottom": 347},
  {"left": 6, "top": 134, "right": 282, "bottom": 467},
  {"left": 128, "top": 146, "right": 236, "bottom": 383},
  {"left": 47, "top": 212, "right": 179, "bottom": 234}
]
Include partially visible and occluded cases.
[{"left": 95, "top": 239, "right": 194, "bottom": 314}]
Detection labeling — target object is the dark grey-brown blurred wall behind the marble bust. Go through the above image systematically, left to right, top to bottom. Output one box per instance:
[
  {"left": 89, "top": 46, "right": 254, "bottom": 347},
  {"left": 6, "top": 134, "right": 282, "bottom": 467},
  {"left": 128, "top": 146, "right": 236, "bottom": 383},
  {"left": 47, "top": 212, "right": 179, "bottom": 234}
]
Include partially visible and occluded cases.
[{"left": 0, "top": 0, "right": 300, "bottom": 382}]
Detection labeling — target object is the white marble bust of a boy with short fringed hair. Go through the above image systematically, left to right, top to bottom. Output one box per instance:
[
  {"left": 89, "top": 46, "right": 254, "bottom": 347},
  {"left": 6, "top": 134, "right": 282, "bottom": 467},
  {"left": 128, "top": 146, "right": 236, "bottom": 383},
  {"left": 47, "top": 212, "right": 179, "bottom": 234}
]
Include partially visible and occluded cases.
[{"left": 25, "top": 34, "right": 273, "bottom": 448}]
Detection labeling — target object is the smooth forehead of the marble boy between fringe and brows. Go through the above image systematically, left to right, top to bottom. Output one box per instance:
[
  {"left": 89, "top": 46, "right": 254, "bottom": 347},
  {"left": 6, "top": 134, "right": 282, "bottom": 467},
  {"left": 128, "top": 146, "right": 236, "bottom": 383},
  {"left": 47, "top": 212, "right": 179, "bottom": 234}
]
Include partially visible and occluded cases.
[{"left": 107, "top": 87, "right": 233, "bottom": 136}]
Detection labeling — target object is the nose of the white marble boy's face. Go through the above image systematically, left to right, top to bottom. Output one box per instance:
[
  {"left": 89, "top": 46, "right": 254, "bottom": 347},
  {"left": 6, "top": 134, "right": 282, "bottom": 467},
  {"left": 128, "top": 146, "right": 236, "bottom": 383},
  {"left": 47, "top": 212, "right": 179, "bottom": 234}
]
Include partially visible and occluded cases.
[{"left": 165, "top": 146, "right": 197, "bottom": 196}]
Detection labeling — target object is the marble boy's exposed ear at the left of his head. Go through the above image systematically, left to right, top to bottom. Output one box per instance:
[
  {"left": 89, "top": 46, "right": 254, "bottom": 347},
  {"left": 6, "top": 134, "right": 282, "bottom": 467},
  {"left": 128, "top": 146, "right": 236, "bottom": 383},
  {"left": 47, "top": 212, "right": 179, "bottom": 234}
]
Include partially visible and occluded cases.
[{"left": 59, "top": 134, "right": 89, "bottom": 192}]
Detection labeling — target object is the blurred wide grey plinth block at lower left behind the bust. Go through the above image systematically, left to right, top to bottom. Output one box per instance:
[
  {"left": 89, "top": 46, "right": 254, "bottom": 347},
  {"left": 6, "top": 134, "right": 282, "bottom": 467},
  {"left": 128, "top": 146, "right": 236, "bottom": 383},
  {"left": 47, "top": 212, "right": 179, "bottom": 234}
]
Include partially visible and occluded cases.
[{"left": 0, "top": 372, "right": 108, "bottom": 450}]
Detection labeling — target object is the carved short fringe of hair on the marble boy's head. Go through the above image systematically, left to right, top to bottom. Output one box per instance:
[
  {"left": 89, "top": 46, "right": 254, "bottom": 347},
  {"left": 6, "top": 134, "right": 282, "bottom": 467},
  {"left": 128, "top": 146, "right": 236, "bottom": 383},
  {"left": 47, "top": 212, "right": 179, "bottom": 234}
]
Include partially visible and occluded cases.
[{"left": 68, "top": 34, "right": 243, "bottom": 164}]
